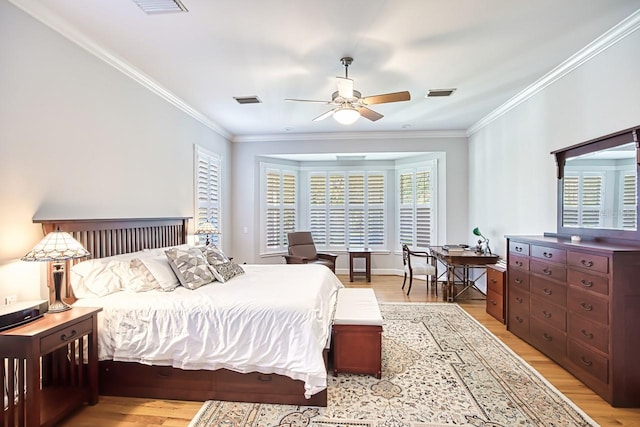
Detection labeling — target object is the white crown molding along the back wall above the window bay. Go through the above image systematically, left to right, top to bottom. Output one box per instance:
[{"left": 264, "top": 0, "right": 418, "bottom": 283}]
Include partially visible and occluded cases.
[{"left": 232, "top": 130, "right": 467, "bottom": 142}]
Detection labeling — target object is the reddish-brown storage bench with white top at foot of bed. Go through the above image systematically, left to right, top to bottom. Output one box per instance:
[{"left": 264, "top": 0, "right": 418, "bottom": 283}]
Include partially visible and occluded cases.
[{"left": 332, "top": 288, "right": 382, "bottom": 378}]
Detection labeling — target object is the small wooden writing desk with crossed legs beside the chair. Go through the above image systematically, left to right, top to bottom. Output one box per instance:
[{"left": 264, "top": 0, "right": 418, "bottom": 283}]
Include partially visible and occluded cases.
[{"left": 430, "top": 246, "right": 500, "bottom": 302}]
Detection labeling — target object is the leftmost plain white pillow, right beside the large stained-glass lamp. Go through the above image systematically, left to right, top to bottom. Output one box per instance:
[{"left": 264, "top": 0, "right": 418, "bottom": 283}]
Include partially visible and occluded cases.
[{"left": 69, "top": 260, "right": 130, "bottom": 298}]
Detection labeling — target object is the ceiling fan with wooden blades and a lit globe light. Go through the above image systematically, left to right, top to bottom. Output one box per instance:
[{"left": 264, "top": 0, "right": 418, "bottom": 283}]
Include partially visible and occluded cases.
[{"left": 285, "top": 56, "right": 411, "bottom": 125}]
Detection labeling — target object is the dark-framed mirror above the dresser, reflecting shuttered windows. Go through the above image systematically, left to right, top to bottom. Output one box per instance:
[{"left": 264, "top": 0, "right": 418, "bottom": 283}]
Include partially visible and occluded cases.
[{"left": 552, "top": 128, "right": 640, "bottom": 240}]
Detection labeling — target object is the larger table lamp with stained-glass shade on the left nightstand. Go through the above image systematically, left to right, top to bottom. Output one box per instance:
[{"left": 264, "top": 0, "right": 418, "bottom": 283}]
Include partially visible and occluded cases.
[{"left": 22, "top": 228, "right": 90, "bottom": 313}]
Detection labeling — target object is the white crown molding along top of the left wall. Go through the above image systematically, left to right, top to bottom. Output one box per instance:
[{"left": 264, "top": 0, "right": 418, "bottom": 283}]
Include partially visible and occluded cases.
[{"left": 9, "top": 0, "right": 231, "bottom": 140}]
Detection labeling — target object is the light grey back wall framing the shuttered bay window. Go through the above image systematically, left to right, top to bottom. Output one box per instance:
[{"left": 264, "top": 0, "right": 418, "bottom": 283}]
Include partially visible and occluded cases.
[{"left": 232, "top": 134, "right": 468, "bottom": 272}]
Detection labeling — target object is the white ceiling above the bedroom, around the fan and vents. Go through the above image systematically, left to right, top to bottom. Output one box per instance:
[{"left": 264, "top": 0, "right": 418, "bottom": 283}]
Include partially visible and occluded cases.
[{"left": 11, "top": 0, "right": 640, "bottom": 139}]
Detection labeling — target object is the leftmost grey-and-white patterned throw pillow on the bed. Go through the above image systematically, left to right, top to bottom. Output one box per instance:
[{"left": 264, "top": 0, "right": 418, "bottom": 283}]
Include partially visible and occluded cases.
[{"left": 165, "top": 248, "right": 215, "bottom": 289}]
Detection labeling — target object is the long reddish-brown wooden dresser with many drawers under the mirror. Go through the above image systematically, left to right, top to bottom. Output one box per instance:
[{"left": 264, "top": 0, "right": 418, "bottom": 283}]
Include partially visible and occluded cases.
[{"left": 506, "top": 236, "right": 640, "bottom": 407}]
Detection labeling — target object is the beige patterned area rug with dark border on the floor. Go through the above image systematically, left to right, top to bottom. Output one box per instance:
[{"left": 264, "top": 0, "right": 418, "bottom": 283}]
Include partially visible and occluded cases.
[{"left": 190, "top": 303, "right": 597, "bottom": 427}]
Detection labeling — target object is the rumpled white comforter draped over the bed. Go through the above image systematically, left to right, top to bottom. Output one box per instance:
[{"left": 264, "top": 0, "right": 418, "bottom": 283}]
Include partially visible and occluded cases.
[{"left": 75, "top": 265, "right": 342, "bottom": 398}]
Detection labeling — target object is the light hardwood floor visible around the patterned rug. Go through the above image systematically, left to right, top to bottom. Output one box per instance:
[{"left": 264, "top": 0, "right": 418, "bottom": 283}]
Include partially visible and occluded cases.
[{"left": 61, "top": 276, "right": 640, "bottom": 427}]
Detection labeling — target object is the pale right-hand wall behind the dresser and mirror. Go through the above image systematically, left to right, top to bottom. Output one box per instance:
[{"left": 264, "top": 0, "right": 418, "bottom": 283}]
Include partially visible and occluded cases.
[{"left": 469, "top": 31, "right": 640, "bottom": 256}]
